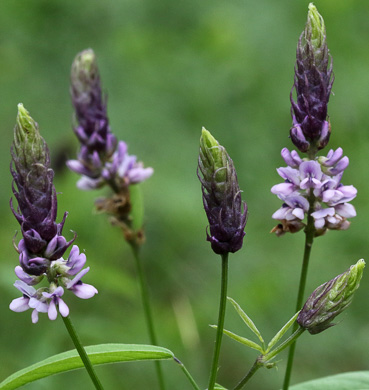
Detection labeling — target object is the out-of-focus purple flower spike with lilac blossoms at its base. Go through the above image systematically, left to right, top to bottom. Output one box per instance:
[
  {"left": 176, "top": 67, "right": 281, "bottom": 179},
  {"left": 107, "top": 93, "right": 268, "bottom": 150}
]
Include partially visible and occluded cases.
[{"left": 67, "top": 49, "right": 153, "bottom": 193}]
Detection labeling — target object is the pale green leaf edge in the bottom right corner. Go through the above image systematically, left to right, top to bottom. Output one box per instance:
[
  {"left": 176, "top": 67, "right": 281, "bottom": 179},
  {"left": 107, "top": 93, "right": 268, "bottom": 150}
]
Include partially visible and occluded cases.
[{"left": 290, "top": 371, "right": 369, "bottom": 390}]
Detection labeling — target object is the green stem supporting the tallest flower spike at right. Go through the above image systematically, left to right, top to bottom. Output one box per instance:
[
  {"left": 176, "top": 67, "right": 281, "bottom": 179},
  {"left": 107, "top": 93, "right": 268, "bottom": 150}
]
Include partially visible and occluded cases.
[{"left": 283, "top": 193, "right": 315, "bottom": 390}]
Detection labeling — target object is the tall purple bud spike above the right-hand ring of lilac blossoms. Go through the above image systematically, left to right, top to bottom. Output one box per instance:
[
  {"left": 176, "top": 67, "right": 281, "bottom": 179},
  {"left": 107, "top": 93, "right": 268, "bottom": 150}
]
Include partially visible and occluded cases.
[{"left": 290, "top": 3, "right": 334, "bottom": 153}]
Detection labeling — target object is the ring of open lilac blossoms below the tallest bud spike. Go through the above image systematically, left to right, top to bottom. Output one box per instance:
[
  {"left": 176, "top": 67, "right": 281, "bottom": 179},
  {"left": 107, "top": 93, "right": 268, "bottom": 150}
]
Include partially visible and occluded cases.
[{"left": 271, "top": 148, "right": 357, "bottom": 235}]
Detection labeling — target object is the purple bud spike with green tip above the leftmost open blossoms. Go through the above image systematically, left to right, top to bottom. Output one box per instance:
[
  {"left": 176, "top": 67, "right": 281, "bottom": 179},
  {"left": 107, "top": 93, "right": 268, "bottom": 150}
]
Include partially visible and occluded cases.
[{"left": 10, "top": 104, "right": 58, "bottom": 253}]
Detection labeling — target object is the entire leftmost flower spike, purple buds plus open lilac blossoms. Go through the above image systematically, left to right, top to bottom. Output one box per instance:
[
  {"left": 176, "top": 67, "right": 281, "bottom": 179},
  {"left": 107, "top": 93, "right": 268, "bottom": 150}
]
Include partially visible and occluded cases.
[{"left": 10, "top": 104, "right": 97, "bottom": 323}]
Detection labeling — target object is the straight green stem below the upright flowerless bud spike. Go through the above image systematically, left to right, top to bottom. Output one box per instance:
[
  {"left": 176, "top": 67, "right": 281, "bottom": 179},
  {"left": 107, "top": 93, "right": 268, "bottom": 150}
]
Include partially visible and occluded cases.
[{"left": 208, "top": 253, "right": 228, "bottom": 390}]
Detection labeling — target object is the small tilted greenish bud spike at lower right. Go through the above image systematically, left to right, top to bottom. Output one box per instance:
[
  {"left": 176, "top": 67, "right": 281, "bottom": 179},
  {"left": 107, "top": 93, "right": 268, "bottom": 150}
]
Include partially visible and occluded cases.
[{"left": 297, "top": 260, "right": 365, "bottom": 334}]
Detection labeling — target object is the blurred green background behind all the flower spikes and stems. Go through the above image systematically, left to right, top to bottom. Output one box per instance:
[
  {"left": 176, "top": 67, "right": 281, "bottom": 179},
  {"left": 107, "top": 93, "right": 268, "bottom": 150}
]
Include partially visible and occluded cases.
[{"left": 0, "top": 0, "right": 369, "bottom": 390}]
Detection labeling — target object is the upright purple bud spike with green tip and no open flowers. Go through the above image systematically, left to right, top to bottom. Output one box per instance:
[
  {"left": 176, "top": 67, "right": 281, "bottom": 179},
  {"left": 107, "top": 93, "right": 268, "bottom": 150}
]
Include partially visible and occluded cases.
[{"left": 198, "top": 128, "right": 247, "bottom": 254}]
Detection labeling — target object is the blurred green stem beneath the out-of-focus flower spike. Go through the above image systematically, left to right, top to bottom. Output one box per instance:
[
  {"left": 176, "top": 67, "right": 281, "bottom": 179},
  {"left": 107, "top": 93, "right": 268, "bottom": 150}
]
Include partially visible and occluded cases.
[{"left": 131, "top": 244, "right": 165, "bottom": 390}]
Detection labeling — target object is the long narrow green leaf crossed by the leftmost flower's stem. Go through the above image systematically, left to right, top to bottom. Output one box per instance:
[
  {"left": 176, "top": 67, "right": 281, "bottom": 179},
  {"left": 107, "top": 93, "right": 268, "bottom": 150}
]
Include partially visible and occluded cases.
[{"left": 0, "top": 344, "right": 174, "bottom": 390}]
